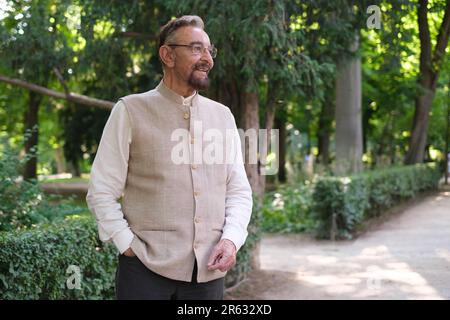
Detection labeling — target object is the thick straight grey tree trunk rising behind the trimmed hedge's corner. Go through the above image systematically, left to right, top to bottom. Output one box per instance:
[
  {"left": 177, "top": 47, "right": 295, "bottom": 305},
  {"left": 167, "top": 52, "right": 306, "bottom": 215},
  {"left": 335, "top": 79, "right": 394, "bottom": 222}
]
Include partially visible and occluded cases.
[{"left": 335, "top": 39, "right": 362, "bottom": 175}]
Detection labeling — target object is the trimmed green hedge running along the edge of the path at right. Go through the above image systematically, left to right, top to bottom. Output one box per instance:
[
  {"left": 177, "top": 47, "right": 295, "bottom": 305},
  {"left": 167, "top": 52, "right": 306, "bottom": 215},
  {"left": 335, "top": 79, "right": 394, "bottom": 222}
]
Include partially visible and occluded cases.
[{"left": 312, "top": 163, "right": 441, "bottom": 239}]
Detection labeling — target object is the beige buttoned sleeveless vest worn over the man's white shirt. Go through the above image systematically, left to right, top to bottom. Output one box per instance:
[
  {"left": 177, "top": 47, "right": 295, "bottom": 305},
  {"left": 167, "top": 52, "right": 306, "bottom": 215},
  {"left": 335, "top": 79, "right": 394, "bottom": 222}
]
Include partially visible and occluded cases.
[{"left": 121, "top": 82, "right": 235, "bottom": 282}]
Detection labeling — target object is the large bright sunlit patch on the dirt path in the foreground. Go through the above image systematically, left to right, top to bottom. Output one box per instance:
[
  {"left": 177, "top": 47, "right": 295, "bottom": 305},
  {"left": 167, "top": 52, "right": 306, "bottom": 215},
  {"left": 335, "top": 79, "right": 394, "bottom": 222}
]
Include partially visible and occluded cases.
[{"left": 262, "top": 245, "right": 444, "bottom": 300}]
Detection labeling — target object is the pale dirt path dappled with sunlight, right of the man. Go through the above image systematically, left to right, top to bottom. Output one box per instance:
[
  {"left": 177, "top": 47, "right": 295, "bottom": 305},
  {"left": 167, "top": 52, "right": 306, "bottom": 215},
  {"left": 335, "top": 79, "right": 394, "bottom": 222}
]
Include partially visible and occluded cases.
[{"left": 226, "top": 190, "right": 450, "bottom": 299}]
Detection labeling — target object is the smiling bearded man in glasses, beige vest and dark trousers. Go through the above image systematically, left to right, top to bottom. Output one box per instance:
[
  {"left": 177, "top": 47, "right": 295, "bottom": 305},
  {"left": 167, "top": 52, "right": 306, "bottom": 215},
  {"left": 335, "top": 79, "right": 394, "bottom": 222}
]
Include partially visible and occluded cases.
[{"left": 86, "top": 16, "right": 252, "bottom": 300}]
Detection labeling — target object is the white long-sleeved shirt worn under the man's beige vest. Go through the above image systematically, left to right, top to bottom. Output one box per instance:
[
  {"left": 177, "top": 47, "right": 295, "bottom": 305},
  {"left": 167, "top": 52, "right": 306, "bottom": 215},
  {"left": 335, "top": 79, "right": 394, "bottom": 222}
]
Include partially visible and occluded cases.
[{"left": 86, "top": 87, "right": 252, "bottom": 253}]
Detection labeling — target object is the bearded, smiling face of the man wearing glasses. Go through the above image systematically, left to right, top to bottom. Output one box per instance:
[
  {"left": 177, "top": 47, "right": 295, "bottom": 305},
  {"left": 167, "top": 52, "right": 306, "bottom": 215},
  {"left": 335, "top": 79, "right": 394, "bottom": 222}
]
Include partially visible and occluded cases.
[{"left": 170, "top": 27, "right": 214, "bottom": 90}]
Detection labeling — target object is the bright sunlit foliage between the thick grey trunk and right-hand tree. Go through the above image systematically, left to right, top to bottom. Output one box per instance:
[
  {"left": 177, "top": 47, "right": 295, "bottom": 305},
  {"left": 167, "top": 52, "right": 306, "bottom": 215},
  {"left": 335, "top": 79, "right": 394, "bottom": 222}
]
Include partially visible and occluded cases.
[{"left": 361, "top": 1, "right": 419, "bottom": 168}]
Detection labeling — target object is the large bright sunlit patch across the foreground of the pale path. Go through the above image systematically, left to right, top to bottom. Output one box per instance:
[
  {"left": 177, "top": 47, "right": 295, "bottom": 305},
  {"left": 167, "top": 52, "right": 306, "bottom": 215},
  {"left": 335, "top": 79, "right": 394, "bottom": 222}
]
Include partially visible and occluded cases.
[{"left": 297, "top": 246, "right": 442, "bottom": 299}]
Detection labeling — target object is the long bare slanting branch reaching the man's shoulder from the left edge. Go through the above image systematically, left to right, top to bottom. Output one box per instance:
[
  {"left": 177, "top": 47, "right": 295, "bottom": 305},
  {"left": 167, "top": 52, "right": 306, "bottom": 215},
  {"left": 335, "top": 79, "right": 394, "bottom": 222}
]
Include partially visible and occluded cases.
[{"left": 0, "top": 75, "right": 114, "bottom": 110}]
